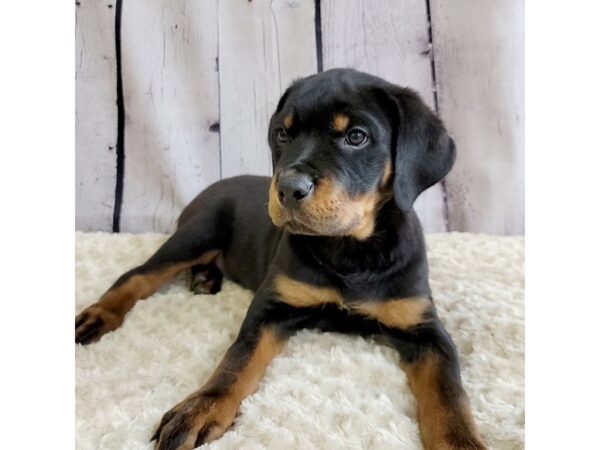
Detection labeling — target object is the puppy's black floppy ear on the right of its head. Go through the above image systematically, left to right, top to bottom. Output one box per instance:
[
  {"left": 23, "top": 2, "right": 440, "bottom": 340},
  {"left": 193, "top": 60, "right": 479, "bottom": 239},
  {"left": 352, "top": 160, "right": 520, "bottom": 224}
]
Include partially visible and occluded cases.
[{"left": 387, "top": 86, "right": 456, "bottom": 211}]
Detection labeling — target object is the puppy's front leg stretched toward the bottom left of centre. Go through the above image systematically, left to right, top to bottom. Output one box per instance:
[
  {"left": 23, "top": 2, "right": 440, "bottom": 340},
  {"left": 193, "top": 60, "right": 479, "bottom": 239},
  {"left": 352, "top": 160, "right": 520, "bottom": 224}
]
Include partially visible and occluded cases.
[{"left": 152, "top": 294, "right": 286, "bottom": 450}]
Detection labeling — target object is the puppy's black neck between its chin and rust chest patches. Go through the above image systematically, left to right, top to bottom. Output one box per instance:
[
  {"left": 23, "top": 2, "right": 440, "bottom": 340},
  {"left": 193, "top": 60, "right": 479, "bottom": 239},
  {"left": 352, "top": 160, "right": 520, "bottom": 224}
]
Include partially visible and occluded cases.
[{"left": 290, "top": 199, "right": 427, "bottom": 283}]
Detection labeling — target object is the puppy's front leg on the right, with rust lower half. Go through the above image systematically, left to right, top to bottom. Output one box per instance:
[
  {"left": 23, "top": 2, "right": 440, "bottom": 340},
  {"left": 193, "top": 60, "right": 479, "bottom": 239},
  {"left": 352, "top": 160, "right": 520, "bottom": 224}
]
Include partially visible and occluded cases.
[{"left": 354, "top": 297, "right": 486, "bottom": 450}]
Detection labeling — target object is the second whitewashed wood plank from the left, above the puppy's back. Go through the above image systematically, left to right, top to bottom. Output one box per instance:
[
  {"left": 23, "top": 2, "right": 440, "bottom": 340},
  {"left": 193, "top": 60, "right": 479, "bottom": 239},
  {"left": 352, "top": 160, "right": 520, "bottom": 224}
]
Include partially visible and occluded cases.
[{"left": 121, "top": 0, "right": 220, "bottom": 232}]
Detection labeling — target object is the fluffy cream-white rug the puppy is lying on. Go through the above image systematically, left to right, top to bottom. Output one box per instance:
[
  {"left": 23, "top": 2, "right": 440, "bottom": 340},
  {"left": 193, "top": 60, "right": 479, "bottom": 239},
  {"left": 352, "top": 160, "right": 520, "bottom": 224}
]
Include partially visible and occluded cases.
[{"left": 75, "top": 232, "right": 525, "bottom": 450}]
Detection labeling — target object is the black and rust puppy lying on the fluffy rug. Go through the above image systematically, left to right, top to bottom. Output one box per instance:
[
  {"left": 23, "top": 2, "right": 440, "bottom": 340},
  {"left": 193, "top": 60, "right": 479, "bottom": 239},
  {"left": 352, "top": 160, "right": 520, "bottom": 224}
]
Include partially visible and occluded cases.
[{"left": 75, "top": 69, "right": 485, "bottom": 450}]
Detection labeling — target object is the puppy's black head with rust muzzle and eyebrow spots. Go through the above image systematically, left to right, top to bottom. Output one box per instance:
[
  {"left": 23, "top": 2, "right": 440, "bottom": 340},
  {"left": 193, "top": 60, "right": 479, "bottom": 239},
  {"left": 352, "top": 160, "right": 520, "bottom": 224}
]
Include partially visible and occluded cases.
[{"left": 269, "top": 69, "right": 455, "bottom": 239}]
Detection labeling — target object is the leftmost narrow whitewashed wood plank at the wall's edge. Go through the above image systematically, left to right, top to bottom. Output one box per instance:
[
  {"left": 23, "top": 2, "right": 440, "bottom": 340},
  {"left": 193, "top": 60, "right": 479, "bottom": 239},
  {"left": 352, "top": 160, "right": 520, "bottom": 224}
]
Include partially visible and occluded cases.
[{"left": 75, "top": 0, "right": 117, "bottom": 231}]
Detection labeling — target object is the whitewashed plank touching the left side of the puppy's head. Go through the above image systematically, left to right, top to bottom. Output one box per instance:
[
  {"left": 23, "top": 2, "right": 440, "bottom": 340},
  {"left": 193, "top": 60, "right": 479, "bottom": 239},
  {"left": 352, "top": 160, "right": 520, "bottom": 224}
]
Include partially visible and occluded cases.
[{"left": 219, "top": 0, "right": 317, "bottom": 178}]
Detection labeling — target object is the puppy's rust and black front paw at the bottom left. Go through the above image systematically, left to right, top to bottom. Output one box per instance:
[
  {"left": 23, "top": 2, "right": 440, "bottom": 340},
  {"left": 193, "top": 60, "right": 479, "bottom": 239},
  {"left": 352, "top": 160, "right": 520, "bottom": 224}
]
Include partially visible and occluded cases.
[{"left": 150, "top": 392, "right": 238, "bottom": 450}]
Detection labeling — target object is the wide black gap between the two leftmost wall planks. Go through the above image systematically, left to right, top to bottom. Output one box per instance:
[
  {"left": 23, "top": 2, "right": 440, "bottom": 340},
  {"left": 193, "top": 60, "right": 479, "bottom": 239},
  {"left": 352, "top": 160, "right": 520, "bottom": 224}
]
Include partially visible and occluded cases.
[{"left": 113, "top": 0, "right": 125, "bottom": 233}]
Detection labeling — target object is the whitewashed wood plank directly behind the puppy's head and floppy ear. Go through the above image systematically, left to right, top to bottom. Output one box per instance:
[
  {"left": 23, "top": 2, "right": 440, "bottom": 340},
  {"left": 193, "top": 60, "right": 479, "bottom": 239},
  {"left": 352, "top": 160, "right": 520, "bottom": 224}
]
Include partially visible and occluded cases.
[{"left": 321, "top": 0, "right": 446, "bottom": 232}]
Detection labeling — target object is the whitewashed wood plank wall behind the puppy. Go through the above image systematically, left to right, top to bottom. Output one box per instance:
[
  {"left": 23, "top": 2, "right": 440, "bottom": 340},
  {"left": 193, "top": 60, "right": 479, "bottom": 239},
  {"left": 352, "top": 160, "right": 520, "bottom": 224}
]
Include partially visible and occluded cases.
[{"left": 76, "top": 0, "right": 524, "bottom": 234}]
